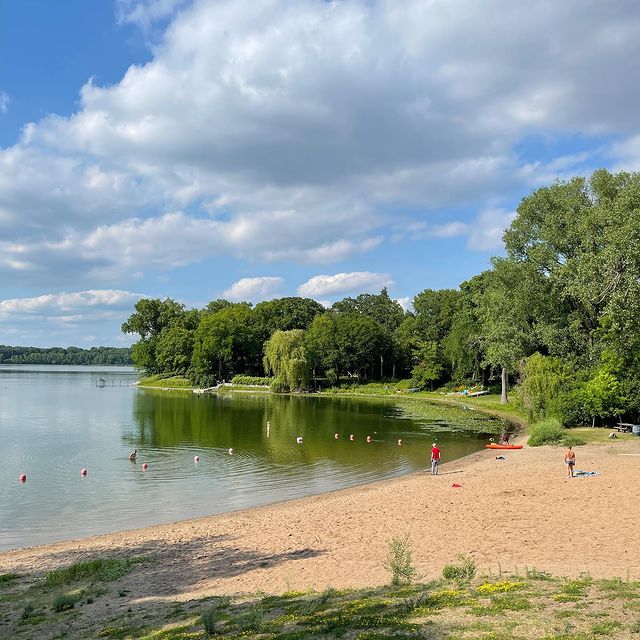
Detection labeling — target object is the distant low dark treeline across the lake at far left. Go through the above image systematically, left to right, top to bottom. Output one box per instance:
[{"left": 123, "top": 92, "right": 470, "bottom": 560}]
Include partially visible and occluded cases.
[{"left": 0, "top": 345, "right": 133, "bottom": 365}]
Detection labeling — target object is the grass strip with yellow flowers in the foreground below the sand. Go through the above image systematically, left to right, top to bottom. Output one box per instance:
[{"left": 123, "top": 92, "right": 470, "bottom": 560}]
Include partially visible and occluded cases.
[{"left": 0, "top": 558, "right": 640, "bottom": 640}]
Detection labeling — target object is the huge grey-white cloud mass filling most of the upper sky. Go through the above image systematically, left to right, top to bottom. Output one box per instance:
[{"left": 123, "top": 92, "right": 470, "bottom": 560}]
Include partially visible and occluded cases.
[{"left": 0, "top": 0, "right": 640, "bottom": 281}]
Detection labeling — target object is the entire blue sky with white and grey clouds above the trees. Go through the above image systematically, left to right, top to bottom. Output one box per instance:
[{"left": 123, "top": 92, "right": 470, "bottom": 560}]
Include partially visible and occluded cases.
[{"left": 0, "top": 0, "right": 640, "bottom": 347}]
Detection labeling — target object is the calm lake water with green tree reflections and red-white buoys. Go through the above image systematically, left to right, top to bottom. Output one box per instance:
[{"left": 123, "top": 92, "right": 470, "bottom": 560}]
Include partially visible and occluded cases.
[{"left": 0, "top": 365, "right": 504, "bottom": 549}]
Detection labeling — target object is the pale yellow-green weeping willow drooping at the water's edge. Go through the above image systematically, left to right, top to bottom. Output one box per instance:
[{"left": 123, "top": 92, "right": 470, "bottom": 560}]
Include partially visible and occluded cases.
[{"left": 263, "top": 329, "right": 310, "bottom": 391}]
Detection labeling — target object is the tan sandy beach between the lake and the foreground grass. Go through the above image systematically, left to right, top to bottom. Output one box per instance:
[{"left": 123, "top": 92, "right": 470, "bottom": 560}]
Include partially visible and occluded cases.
[{"left": 0, "top": 440, "right": 640, "bottom": 603}]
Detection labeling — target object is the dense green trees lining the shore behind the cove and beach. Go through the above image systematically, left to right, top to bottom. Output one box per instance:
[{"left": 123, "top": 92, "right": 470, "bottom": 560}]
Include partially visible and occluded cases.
[{"left": 122, "top": 170, "right": 640, "bottom": 425}]
